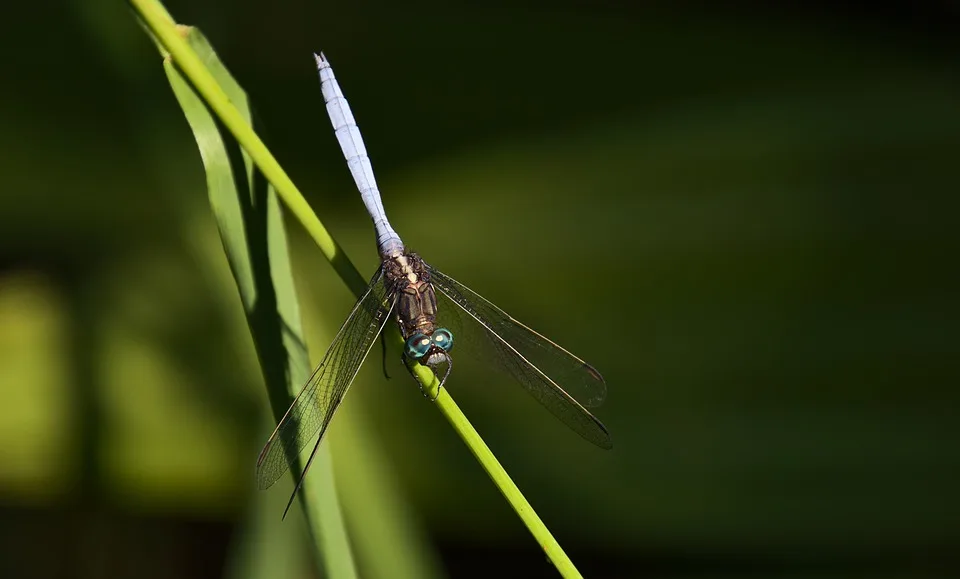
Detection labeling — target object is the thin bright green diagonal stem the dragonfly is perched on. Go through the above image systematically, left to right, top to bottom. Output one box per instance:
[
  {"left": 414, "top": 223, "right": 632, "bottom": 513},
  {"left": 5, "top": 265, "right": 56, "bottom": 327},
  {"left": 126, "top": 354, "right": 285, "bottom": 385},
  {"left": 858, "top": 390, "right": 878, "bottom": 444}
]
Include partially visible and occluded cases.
[{"left": 130, "top": 0, "right": 581, "bottom": 577}]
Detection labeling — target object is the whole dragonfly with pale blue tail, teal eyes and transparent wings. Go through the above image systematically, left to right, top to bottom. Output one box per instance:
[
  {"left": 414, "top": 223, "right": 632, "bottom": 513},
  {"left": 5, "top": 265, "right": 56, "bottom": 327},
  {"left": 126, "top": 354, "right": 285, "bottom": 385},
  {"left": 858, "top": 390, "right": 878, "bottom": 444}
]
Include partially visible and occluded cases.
[{"left": 257, "top": 52, "right": 613, "bottom": 517}]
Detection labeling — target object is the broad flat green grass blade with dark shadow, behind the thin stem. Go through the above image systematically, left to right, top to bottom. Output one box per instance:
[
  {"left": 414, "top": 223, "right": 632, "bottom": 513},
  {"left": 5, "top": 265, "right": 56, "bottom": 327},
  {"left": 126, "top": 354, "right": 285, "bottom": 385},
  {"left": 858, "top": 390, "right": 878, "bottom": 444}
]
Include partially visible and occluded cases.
[{"left": 164, "top": 23, "right": 357, "bottom": 578}]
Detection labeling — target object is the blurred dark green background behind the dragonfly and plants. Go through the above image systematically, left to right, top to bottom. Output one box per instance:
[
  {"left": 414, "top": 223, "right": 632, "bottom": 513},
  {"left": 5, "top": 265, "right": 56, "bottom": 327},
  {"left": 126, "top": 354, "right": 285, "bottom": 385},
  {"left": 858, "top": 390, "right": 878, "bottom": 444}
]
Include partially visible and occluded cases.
[{"left": 0, "top": 0, "right": 960, "bottom": 578}]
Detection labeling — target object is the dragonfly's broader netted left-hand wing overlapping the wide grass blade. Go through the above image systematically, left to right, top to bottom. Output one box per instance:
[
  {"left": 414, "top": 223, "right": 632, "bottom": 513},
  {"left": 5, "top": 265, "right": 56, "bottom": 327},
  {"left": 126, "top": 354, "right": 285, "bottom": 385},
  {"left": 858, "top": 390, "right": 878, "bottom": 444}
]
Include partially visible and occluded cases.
[{"left": 257, "top": 267, "right": 395, "bottom": 489}]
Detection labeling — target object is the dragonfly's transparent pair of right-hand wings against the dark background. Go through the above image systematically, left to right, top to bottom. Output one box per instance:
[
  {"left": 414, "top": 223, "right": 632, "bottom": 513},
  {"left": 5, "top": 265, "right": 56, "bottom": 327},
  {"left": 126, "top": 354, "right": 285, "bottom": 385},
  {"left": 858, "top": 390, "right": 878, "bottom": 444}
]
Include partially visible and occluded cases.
[{"left": 428, "top": 266, "right": 613, "bottom": 449}]
